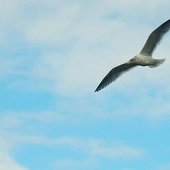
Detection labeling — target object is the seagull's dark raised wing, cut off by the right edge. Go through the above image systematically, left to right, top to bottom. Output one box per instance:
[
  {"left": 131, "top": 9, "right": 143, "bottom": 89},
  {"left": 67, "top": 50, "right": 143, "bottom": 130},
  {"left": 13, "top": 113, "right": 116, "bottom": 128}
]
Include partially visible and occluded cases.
[{"left": 140, "top": 20, "right": 170, "bottom": 56}]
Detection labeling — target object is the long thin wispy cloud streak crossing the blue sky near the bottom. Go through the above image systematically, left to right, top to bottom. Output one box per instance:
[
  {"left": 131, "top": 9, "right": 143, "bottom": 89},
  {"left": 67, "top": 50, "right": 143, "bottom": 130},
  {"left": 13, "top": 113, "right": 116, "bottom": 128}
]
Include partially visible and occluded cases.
[{"left": 6, "top": 135, "right": 145, "bottom": 160}]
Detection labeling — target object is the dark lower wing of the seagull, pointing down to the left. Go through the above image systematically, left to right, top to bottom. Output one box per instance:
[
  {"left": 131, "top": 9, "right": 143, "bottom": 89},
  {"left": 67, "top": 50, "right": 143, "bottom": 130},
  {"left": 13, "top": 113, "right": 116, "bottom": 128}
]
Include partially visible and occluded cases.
[{"left": 95, "top": 62, "right": 137, "bottom": 92}]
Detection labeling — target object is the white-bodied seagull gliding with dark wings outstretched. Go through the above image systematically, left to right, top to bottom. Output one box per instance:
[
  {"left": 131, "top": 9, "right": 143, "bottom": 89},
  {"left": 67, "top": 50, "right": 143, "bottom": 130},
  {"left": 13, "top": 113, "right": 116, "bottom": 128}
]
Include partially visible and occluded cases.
[{"left": 95, "top": 19, "right": 170, "bottom": 92}]
